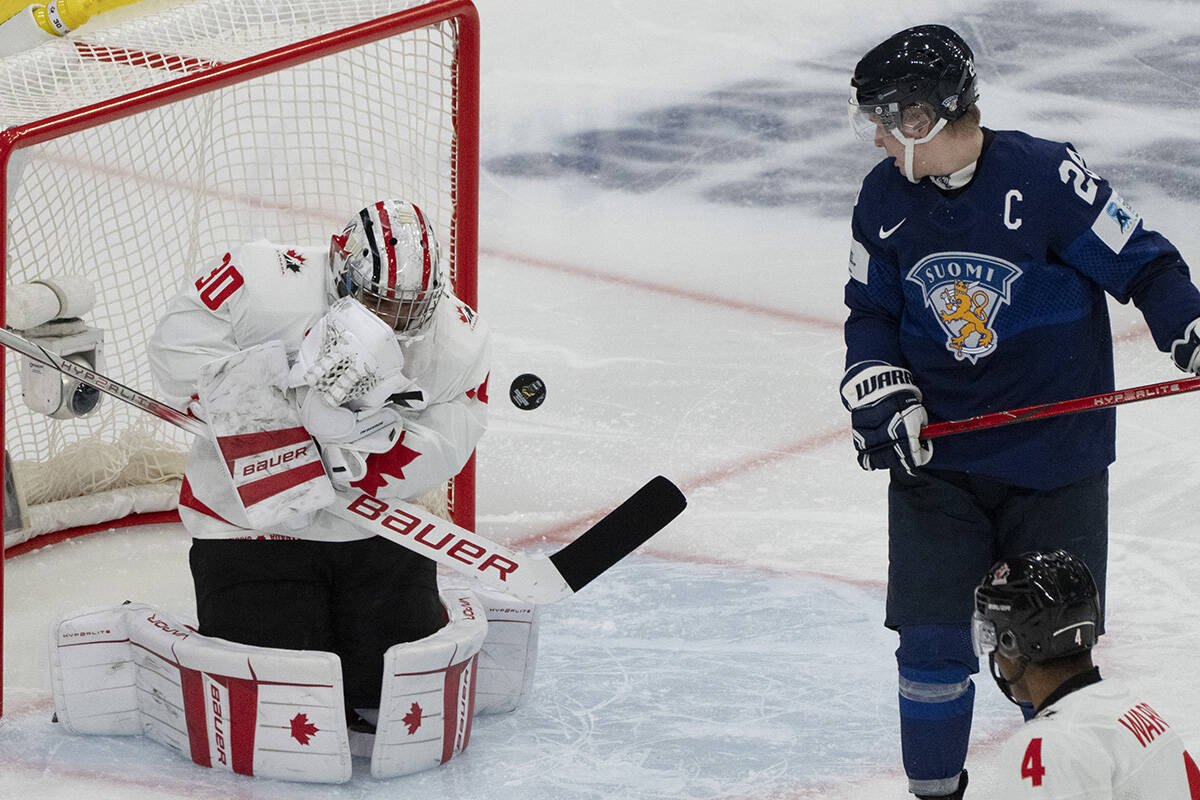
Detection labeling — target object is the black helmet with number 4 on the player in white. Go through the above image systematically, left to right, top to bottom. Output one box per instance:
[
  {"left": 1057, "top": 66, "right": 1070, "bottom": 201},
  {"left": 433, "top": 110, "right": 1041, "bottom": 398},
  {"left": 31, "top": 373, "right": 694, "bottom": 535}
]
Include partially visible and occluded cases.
[{"left": 972, "top": 549, "right": 1100, "bottom": 663}]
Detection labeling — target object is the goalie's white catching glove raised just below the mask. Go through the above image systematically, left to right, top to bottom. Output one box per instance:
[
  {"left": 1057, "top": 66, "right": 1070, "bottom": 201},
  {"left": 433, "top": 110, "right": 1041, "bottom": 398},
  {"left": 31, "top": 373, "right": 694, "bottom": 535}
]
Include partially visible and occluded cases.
[{"left": 290, "top": 297, "right": 424, "bottom": 411}]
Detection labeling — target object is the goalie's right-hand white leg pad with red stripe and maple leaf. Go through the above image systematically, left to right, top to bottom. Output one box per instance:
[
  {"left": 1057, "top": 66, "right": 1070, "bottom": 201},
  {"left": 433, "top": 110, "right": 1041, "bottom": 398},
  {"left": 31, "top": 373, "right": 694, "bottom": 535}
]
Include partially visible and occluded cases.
[{"left": 371, "top": 589, "right": 487, "bottom": 778}]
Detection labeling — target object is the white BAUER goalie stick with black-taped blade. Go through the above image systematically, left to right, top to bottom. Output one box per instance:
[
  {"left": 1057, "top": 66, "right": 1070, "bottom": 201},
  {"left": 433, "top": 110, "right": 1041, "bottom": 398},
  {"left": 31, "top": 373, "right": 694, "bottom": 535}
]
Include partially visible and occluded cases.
[{"left": 0, "top": 327, "right": 688, "bottom": 603}]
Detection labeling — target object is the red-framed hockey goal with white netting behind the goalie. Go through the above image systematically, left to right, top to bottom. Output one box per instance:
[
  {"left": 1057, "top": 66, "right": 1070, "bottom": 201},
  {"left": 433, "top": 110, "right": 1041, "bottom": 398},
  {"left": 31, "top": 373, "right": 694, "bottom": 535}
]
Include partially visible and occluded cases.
[{"left": 0, "top": 0, "right": 479, "bottom": 715}]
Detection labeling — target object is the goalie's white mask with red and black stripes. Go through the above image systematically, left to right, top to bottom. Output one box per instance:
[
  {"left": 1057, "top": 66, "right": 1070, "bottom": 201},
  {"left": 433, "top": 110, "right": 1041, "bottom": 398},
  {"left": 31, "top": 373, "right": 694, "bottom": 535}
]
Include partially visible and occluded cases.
[{"left": 329, "top": 199, "right": 446, "bottom": 333}]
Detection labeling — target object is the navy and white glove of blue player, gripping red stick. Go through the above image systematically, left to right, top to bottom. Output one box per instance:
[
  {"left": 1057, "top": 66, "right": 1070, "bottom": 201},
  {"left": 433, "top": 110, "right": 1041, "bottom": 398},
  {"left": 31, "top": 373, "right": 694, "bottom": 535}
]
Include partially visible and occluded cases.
[{"left": 841, "top": 361, "right": 934, "bottom": 475}]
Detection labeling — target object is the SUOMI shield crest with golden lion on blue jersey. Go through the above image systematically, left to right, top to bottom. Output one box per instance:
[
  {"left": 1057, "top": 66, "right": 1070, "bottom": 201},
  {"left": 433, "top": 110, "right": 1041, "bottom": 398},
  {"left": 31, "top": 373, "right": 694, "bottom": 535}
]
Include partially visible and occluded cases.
[{"left": 906, "top": 253, "right": 1021, "bottom": 363}]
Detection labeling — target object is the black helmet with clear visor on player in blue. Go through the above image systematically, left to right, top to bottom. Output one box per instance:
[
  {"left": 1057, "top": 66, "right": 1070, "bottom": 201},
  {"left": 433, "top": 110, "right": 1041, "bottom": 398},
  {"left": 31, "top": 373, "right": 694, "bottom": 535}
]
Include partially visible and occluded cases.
[{"left": 850, "top": 25, "right": 979, "bottom": 139}]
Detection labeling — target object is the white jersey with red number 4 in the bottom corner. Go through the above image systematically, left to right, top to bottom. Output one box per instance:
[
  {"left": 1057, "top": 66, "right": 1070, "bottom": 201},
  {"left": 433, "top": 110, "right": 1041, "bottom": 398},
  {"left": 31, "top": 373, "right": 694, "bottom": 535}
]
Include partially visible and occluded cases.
[{"left": 996, "top": 680, "right": 1200, "bottom": 800}]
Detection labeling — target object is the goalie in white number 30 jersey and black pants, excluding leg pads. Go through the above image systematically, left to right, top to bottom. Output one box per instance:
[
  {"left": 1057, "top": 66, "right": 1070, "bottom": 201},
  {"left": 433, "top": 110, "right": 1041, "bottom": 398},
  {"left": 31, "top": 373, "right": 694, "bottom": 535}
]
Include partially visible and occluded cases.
[{"left": 150, "top": 199, "right": 501, "bottom": 777}]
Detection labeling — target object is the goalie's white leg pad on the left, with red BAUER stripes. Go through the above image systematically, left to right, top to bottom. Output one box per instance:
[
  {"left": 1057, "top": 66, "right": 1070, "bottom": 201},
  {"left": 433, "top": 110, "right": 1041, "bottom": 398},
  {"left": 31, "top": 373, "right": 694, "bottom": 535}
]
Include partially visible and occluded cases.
[{"left": 50, "top": 604, "right": 350, "bottom": 783}]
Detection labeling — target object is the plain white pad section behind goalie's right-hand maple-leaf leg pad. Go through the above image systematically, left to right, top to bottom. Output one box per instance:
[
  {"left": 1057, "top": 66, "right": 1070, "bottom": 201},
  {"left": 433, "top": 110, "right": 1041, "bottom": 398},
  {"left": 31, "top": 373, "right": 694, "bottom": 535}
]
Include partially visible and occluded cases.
[{"left": 473, "top": 588, "right": 541, "bottom": 714}]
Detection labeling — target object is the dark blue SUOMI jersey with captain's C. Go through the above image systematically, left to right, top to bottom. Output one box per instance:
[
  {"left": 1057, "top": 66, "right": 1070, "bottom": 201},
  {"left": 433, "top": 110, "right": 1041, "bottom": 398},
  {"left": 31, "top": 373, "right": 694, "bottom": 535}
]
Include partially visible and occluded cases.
[{"left": 845, "top": 131, "right": 1200, "bottom": 488}]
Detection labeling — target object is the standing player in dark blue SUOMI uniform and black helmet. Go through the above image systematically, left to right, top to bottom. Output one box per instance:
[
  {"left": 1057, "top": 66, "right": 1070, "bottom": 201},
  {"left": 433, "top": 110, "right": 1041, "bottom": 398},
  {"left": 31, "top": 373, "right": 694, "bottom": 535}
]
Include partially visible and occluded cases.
[{"left": 841, "top": 25, "right": 1200, "bottom": 798}]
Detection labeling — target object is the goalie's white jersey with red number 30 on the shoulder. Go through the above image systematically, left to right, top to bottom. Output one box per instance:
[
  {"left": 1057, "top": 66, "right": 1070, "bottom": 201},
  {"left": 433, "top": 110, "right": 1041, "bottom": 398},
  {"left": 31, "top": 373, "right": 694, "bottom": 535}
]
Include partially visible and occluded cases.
[{"left": 149, "top": 241, "right": 491, "bottom": 541}]
